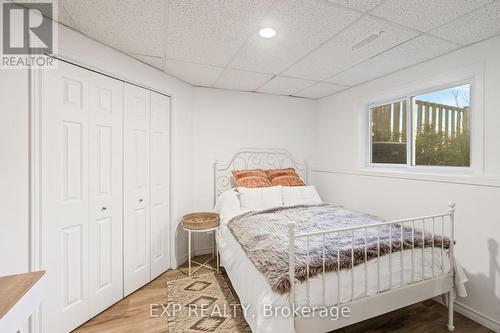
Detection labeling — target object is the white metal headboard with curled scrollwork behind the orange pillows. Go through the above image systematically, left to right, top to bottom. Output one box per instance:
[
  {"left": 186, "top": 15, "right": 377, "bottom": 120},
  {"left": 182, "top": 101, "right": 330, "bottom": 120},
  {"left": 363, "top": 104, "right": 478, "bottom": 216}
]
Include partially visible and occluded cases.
[{"left": 214, "top": 148, "right": 309, "bottom": 201}]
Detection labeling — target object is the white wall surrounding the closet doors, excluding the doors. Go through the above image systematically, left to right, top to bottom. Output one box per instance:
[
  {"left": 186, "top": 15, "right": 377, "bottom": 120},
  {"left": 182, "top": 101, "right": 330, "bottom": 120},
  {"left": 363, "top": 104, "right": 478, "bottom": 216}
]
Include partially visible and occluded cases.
[{"left": 0, "top": 22, "right": 193, "bottom": 275}]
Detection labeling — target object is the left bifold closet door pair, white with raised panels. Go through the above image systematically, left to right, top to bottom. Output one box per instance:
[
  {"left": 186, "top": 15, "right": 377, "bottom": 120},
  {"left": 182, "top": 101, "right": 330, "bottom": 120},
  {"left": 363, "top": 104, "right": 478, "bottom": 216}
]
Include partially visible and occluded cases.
[{"left": 41, "top": 61, "right": 123, "bottom": 333}]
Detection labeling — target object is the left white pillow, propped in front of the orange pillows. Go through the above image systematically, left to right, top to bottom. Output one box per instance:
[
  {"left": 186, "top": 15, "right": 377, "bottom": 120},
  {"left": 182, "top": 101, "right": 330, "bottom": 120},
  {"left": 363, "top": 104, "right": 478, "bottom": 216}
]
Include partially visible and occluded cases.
[{"left": 238, "top": 186, "right": 283, "bottom": 210}]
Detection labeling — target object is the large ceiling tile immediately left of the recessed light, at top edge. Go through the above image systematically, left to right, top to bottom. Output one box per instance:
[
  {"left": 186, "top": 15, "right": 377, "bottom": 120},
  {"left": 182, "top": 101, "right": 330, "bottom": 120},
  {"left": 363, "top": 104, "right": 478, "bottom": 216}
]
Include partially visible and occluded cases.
[{"left": 167, "top": 0, "right": 273, "bottom": 66}]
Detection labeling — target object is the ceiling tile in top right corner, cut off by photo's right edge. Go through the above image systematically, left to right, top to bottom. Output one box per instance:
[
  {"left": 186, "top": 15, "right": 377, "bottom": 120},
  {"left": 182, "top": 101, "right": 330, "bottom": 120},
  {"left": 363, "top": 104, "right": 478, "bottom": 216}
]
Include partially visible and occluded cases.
[{"left": 430, "top": 0, "right": 500, "bottom": 45}]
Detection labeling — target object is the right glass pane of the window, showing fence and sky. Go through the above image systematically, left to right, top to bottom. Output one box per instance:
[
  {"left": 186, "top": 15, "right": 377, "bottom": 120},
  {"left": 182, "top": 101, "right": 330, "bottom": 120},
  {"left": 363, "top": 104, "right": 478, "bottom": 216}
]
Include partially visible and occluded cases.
[{"left": 412, "top": 84, "right": 470, "bottom": 167}]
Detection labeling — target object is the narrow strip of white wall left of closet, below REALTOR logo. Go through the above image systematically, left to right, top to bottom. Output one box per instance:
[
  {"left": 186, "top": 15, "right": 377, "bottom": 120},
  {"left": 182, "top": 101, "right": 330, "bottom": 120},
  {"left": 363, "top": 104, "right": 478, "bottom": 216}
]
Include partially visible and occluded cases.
[{"left": 0, "top": 70, "right": 29, "bottom": 275}]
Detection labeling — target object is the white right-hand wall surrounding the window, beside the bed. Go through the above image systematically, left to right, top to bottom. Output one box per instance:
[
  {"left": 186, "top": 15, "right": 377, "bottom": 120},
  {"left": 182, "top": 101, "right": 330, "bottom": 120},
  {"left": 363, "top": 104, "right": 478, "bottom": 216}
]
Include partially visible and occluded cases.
[{"left": 313, "top": 38, "right": 500, "bottom": 329}]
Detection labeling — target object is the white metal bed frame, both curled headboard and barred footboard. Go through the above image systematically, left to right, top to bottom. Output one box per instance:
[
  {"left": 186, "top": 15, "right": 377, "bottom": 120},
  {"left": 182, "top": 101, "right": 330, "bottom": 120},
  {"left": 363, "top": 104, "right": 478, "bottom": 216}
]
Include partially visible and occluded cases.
[{"left": 214, "top": 148, "right": 455, "bottom": 333}]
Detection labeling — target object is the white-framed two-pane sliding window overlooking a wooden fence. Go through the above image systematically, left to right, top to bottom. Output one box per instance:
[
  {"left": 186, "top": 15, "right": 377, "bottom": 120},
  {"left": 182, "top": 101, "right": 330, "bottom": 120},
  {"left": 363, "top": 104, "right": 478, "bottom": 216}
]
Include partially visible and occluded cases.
[{"left": 369, "top": 84, "right": 471, "bottom": 167}]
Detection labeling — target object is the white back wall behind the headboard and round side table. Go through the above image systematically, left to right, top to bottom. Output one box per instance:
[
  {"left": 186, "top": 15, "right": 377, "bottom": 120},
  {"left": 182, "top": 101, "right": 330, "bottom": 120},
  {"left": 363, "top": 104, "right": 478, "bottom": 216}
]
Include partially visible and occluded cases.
[{"left": 193, "top": 88, "right": 316, "bottom": 253}]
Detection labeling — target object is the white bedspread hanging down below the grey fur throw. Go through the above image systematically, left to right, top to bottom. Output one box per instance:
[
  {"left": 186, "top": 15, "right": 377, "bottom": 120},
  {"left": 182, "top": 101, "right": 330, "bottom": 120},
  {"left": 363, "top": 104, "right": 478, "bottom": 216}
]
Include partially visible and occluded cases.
[{"left": 219, "top": 214, "right": 466, "bottom": 333}]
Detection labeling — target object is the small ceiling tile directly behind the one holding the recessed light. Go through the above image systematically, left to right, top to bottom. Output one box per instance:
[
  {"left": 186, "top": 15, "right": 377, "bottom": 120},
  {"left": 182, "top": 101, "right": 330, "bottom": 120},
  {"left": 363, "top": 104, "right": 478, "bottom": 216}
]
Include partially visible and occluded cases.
[{"left": 214, "top": 69, "right": 273, "bottom": 91}]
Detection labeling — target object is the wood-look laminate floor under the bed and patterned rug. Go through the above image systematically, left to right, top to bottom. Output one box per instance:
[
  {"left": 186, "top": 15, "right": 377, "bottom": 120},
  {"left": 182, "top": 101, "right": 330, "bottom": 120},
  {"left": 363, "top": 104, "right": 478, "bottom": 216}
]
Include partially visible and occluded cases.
[{"left": 73, "top": 257, "right": 492, "bottom": 333}]
